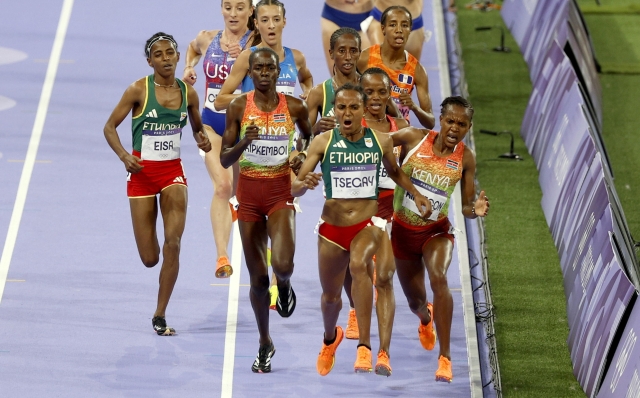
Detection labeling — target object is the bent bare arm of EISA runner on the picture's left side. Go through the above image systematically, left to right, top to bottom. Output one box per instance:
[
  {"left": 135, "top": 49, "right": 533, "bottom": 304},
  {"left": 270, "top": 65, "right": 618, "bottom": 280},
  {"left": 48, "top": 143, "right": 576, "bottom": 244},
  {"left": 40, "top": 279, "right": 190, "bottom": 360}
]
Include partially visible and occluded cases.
[{"left": 103, "top": 78, "right": 146, "bottom": 173}]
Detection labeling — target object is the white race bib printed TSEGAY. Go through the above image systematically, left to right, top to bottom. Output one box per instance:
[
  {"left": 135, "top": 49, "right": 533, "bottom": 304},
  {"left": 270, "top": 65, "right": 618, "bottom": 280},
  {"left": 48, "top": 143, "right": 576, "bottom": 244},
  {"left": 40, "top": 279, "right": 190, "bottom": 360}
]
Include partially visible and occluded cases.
[{"left": 331, "top": 164, "right": 377, "bottom": 199}]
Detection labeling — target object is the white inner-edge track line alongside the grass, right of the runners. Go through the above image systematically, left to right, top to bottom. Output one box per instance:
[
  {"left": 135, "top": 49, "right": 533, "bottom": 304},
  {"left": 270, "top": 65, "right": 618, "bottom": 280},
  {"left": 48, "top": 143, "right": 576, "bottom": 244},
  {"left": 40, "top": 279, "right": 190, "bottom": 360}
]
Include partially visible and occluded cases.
[{"left": 433, "top": 0, "right": 483, "bottom": 398}]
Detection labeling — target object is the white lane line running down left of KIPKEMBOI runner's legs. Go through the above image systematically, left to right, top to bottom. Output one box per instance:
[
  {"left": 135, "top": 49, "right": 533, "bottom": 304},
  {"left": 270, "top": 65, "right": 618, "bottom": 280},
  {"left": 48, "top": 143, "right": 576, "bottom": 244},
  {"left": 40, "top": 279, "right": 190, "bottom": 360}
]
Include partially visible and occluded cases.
[{"left": 220, "top": 221, "right": 242, "bottom": 398}]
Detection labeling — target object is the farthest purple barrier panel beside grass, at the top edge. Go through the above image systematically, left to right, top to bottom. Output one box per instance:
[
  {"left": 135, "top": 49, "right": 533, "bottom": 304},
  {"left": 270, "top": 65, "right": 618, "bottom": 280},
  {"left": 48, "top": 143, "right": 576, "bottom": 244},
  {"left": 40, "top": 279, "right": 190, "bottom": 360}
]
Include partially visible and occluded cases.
[{"left": 520, "top": 0, "right": 569, "bottom": 81}]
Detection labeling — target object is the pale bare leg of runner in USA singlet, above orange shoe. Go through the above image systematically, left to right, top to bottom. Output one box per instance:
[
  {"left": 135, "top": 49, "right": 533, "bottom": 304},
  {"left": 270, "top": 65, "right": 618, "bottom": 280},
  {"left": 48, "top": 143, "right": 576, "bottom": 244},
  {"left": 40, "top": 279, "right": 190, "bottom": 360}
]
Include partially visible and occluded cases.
[{"left": 203, "top": 124, "right": 234, "bottom": 258}]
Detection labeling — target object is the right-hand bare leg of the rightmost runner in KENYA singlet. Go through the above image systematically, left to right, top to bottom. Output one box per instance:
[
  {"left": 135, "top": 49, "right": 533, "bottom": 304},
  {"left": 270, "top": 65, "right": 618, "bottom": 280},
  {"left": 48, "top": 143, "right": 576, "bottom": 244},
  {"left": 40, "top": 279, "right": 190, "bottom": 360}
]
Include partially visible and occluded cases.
[{"left": 422, "top": 236, "right": 453, "bottom": 359}]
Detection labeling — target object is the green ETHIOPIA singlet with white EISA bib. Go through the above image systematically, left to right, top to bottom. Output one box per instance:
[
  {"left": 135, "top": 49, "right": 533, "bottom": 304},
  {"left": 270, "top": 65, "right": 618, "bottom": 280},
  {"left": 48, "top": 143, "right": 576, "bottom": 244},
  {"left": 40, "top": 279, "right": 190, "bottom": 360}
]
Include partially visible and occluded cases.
[{"left": 131, "top": 75, "right": 187, "bottom": 161}]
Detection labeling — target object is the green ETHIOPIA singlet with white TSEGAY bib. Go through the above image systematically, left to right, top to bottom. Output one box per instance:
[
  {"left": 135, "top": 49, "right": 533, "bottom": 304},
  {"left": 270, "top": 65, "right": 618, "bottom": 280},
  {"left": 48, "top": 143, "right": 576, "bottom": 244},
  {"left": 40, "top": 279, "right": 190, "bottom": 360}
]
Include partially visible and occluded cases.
[{"left": 321, "top": 127, "right": 382, "bottom": 199}]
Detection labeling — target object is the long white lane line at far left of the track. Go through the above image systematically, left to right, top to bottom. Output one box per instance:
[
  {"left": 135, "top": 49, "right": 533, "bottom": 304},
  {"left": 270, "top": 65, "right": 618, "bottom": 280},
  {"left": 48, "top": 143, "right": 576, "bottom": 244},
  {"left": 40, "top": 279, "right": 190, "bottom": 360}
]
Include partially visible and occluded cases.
[{"left": 0, "top": 0, "right": 73, "bottom": 303}]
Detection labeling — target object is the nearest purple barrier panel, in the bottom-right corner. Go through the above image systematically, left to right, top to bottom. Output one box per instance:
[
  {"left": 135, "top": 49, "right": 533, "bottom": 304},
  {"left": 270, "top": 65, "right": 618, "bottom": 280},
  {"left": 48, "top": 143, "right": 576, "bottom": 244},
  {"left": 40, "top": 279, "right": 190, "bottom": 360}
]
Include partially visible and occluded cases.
[{"left": 597, "top": 296, "right": 640, "bottom": 398}]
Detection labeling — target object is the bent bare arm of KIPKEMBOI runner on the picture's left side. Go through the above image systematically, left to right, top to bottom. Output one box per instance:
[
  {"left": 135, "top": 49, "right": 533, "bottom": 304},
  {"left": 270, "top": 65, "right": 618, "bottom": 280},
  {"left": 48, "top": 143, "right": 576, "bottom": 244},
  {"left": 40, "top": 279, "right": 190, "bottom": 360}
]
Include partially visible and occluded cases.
[{"left": 220, "top": 94, "right": 251, "bottom": 169}]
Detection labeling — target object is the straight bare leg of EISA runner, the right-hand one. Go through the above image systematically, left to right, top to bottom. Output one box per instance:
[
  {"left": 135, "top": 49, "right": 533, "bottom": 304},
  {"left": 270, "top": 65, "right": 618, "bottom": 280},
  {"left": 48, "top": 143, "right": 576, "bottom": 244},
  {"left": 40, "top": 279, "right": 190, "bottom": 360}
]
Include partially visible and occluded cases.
[{"left": 154, "top": 185, "right": 187, "bottom": 316}]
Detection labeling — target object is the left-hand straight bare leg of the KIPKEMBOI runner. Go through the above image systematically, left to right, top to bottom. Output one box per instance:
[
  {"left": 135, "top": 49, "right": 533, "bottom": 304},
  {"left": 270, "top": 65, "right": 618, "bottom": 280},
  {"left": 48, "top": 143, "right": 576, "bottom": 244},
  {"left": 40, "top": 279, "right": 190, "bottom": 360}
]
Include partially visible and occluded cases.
[{"left": 238, "top": 220, "right": 271, "bottom": 346}]
